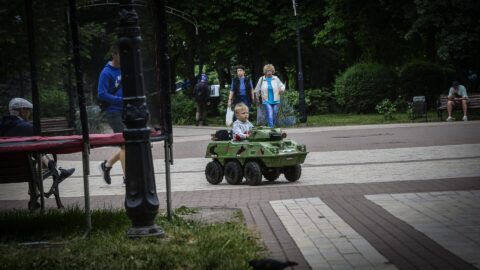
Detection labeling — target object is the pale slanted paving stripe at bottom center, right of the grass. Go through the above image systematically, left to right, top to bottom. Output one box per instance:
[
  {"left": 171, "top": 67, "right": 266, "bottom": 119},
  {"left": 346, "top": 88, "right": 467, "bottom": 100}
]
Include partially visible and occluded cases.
[{"left": 270, "top": 198, "right": 397, "bottom": 269}]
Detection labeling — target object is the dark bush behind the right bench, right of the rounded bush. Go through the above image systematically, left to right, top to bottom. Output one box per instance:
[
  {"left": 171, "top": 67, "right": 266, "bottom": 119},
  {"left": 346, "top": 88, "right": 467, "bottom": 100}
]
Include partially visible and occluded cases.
[{"left": 399, "top": 61, "right": 454, "bottom": 108}]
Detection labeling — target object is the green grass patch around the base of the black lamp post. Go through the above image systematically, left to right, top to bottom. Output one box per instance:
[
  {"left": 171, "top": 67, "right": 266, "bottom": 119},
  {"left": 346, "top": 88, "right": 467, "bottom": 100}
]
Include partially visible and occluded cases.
[{"left": 0, "top": 208, "right": 266, "bottom": 269}]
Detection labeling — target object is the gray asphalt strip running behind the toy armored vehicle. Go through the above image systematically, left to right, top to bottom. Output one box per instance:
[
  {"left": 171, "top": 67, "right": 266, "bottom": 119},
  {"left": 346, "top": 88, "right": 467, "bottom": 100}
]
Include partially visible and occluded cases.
[{"left": 62, "top": 121, "right": 480, "bottom": 160}]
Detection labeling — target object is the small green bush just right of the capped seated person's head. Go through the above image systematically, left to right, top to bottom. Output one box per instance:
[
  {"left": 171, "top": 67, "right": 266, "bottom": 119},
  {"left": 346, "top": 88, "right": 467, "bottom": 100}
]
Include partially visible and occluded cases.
[{"left": 40, "top": 89, "right": 69, "bottom": 117}]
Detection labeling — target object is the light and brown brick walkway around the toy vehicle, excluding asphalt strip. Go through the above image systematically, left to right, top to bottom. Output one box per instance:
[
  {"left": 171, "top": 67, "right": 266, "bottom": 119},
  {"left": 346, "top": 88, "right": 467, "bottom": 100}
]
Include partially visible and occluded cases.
[{"left": 0, "top": 123, "right": 480, "bottom": 269}]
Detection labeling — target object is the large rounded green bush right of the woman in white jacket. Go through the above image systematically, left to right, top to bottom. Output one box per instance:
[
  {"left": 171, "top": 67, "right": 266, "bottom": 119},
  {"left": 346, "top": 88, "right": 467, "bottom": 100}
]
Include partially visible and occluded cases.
[{"left": 334, "top": 63, "right": 397, "bottom": 113}]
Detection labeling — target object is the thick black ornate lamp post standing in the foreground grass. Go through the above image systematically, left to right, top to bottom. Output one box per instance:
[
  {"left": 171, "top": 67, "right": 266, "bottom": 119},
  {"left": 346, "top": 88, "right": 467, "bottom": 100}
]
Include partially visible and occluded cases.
[{"left": 118, "top": 0, "right": 165, "bottom": 238}]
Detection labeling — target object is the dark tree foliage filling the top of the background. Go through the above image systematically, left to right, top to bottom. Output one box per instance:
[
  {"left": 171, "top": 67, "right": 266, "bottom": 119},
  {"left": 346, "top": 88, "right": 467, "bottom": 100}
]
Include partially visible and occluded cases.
[{"left": 0, "top": 0, "right": 480, "bottom": 116}]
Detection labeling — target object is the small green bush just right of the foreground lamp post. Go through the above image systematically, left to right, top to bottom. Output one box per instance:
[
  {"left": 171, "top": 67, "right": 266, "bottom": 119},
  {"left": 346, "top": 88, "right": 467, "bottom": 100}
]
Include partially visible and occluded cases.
[{"left": 172, "top": 92, "right": 197, "bottom": 125}]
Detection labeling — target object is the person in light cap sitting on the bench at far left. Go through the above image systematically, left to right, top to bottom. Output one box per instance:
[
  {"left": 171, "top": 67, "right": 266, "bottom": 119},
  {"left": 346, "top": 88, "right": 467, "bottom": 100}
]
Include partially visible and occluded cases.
[{"left": 0, "top": 98, "right": 75, "bottom": 208}]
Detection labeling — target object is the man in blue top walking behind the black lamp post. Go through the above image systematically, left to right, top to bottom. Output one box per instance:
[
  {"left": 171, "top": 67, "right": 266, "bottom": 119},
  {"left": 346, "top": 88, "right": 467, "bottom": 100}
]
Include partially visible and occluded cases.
[{"left": 98, "top": 45, "right": 125, "bottom": 184}]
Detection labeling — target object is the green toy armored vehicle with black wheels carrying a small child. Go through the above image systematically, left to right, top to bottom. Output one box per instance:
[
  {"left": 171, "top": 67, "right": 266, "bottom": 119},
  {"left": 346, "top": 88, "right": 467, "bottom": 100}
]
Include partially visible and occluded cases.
[{"left": 205, "top": 128, "right": 308, "bottom": 186}]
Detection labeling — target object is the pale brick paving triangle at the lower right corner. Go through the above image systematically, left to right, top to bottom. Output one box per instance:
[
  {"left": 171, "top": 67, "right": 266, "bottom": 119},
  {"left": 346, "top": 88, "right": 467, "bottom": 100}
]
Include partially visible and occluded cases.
[{"left": 366, "top": 190, "right": 480, "bottom": 268}]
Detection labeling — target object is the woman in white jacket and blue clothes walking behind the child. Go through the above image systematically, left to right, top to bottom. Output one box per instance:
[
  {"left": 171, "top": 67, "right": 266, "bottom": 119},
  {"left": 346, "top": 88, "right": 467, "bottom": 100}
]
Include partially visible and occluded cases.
[{"left": 255, "top": 64, "right": 285, "bottom": 128}]
